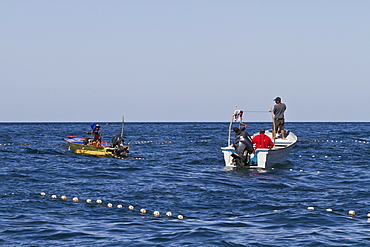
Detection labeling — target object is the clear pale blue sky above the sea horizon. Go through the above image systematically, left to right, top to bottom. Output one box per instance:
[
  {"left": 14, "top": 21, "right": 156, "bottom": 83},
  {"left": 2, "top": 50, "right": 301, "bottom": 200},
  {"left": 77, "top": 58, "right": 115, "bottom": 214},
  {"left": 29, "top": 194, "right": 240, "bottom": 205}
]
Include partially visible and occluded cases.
[{"left": 0, "top": 0, "right": 370, "bottom": 122}]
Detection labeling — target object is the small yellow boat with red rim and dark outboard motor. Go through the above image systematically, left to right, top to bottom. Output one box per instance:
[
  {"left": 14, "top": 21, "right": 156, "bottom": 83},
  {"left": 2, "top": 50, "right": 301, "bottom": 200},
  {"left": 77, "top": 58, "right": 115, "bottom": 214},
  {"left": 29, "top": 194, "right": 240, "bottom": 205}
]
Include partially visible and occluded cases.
[{"left": 64, "top": 135, "right": 130, "bottom": 158}]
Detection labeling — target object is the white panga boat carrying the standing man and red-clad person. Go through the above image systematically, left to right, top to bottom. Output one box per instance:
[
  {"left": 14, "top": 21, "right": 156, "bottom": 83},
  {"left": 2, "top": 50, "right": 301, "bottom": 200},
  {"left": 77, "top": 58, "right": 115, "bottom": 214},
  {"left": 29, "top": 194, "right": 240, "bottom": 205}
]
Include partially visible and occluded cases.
[{"left": 221, "top": 107, "right": 297, "bottom": 169}]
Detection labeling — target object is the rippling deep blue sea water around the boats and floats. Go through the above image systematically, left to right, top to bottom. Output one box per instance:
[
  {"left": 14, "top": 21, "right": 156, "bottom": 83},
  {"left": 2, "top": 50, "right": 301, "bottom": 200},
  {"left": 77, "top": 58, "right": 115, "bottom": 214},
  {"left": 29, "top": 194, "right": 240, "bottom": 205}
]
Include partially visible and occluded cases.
[{"left": 0, "top": 123, "right": 370, "bottom": 246}]
